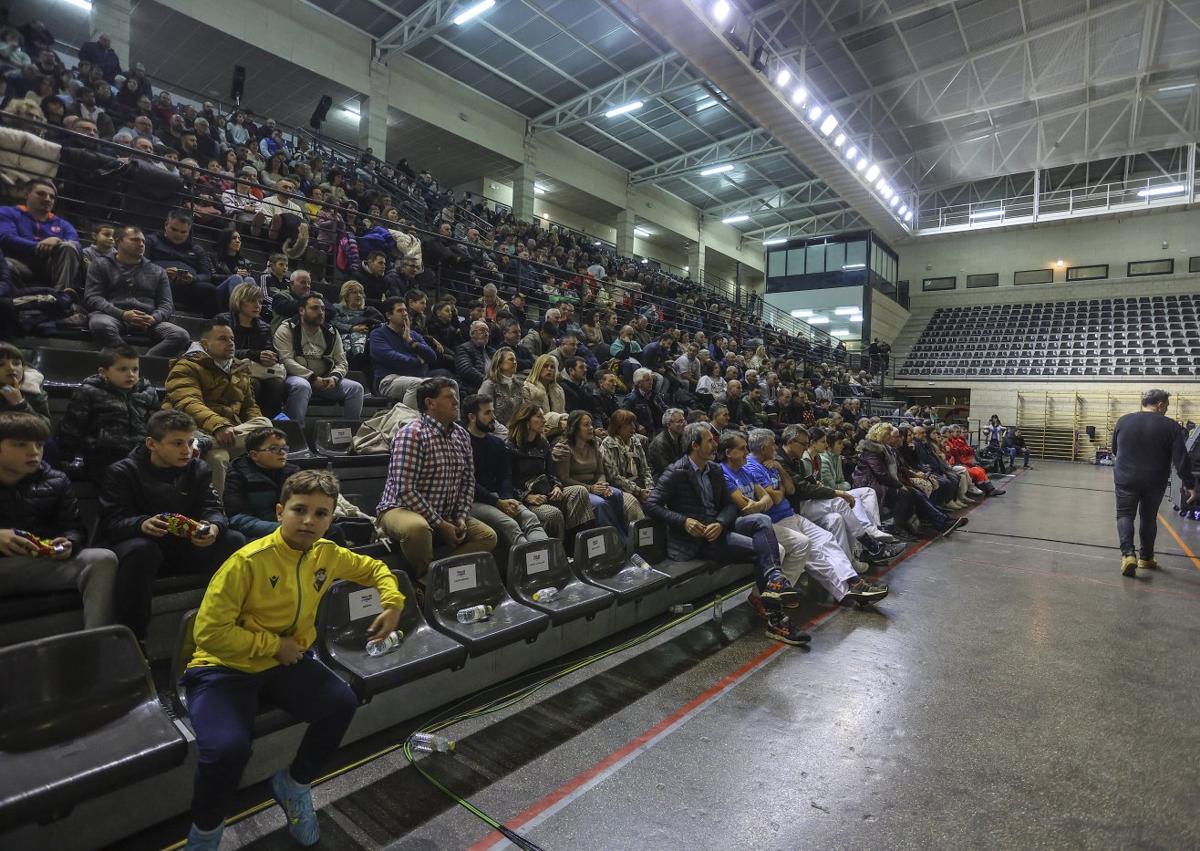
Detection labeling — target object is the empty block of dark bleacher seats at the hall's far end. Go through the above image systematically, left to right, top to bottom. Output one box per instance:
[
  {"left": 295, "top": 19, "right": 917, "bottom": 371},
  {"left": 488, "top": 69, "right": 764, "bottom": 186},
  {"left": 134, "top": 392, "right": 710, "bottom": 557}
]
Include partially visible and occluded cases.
[{"left": 900, "top": 294, "right": 1200, "bottom": 378}]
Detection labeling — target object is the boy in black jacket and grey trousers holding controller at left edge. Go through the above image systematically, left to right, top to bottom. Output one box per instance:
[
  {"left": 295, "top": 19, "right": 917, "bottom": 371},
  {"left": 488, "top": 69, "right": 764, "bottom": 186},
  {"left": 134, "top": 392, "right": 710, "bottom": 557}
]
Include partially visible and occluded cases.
[{"left": 0, "top": 412, "right": 116, "bottom": 629}]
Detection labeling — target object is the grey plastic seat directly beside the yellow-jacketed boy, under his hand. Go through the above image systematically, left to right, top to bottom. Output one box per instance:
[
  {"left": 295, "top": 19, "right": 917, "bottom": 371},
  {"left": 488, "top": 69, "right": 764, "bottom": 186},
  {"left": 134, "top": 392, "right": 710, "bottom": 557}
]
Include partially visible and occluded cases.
[{"left": 317, "top": 573, "right": 467, "bottom": 700}]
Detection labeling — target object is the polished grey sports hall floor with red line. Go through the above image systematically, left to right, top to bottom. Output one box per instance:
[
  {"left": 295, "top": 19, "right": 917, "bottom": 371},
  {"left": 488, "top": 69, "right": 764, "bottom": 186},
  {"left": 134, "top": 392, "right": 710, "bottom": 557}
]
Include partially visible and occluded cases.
[{"left": 133, "top": 463, "right": 1200, "bottom": 851}]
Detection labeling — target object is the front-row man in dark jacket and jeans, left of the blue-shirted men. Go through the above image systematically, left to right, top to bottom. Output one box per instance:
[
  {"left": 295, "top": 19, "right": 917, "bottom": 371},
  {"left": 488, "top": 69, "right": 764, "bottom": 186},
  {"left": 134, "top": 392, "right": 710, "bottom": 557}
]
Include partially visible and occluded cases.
[{"left": 646, "top": 422, "right": 808, "bottom": 645}]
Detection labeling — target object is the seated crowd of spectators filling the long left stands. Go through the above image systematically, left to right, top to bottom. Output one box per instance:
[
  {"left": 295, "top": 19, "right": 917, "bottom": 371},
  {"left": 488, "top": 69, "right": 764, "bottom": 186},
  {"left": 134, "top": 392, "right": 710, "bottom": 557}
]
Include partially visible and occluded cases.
[{"left": 0, "top": 19, "right": 1017, "bottom": 643}]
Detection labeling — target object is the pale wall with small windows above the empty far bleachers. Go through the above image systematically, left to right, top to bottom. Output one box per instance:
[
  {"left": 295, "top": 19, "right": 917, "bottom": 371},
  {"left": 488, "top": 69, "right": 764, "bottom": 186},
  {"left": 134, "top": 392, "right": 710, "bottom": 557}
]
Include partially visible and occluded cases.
[{"left": 898, "top": 209, "right": 1200, "bottom": 302}]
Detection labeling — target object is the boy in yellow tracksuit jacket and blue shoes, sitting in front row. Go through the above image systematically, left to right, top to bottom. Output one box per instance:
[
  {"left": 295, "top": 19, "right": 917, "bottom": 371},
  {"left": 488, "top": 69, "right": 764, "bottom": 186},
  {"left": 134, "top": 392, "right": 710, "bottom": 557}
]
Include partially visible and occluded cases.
[{"left": 180, "top": 471, "right": 404, "bottom": 851}]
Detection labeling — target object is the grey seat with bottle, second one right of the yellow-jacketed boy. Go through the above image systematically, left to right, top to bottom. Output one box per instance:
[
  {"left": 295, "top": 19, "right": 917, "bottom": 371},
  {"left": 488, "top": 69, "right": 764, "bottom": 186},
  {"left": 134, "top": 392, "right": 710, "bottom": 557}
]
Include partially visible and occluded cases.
[{"left": 425, "top": 552, "right": 550, "bottom": 657}]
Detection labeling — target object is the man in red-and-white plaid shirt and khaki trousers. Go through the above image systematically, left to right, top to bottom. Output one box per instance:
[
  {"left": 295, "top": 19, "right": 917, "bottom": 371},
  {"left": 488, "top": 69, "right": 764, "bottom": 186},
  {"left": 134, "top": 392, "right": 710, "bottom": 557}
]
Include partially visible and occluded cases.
[{"left": 377, "top": 378, "right": 496, "bottom": 583}]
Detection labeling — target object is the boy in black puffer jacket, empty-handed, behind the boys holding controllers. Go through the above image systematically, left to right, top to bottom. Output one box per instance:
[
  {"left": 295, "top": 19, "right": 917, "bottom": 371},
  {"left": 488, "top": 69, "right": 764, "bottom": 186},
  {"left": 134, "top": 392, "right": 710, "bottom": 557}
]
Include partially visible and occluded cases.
[{"left": 59, "top": 346, "right": 158, "bottom": 485}]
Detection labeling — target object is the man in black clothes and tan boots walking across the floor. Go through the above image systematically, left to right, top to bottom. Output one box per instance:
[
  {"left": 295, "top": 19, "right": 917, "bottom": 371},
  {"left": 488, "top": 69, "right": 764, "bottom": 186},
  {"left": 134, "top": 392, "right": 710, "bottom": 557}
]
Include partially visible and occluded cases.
[{"left": 1112, "top": 390, "right": 1196, "bottom": 576}]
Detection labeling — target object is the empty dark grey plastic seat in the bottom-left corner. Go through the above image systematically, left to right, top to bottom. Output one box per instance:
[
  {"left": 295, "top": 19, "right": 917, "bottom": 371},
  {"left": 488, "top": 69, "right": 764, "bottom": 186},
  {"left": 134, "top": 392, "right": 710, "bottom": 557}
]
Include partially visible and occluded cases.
[{"left": 0, "top": 627, "right": 187, "bottom": 831}]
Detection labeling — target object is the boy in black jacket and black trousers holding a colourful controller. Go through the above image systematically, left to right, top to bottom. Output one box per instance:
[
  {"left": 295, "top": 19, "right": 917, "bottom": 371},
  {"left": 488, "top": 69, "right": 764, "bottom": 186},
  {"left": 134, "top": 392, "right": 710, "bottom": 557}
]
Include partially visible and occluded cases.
[{"left": 100, "top": 410, "right": 246, "bottom": 641}]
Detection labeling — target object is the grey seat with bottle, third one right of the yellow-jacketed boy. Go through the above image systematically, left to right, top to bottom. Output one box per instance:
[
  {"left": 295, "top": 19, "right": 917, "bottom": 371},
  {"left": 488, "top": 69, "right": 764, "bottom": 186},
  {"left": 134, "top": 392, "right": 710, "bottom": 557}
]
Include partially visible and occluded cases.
[{"left": 508, "top": 539, "right": 617, "bottom": 627}]
